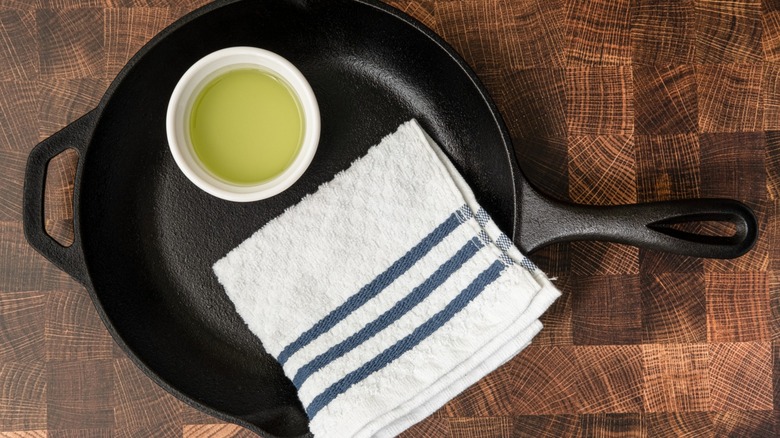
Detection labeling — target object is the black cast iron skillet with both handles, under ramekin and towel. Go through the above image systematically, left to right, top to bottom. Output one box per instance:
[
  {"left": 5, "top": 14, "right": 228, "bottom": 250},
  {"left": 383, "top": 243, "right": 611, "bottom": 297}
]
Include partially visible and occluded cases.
[{"left": 24, "top": 0, "right": 756, "bottom": 436}]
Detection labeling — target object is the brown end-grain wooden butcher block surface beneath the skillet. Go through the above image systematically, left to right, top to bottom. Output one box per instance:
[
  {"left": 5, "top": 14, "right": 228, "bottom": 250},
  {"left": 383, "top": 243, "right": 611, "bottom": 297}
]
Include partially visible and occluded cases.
[{"left": 0, "top": 0, "right": 780, "bottom": 438}]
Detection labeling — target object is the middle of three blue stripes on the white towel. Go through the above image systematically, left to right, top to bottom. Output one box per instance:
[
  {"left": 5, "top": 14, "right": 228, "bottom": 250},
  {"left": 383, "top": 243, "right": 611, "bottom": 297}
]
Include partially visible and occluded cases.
[{"left": 293, "top": 237, "right": 484, "bottom": 389}]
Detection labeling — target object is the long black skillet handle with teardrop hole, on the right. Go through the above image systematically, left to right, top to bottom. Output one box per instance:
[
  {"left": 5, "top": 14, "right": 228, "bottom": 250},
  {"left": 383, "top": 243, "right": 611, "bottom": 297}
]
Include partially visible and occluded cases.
[{"left": 519, "top": 183, "right": 758, "bottom": 259}]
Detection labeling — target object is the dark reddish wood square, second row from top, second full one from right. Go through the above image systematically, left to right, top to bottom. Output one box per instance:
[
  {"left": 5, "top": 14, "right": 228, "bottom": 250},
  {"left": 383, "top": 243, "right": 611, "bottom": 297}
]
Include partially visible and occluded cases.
[{"left": 633, "top": 65, "right": 698, "bottom": 134}]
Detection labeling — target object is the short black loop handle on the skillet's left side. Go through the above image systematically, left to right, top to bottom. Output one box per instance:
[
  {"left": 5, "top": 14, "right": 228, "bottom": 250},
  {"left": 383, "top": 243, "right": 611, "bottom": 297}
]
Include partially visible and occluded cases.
[{"left": 23, "top": 110, "right": 97, "bottom": 284}]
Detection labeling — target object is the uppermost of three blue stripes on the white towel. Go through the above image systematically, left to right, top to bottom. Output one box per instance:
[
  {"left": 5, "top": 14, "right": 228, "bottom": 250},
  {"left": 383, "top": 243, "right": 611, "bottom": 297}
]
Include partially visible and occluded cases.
[{"left": 277, "top": 212, "right": 463, "bottom": 365}]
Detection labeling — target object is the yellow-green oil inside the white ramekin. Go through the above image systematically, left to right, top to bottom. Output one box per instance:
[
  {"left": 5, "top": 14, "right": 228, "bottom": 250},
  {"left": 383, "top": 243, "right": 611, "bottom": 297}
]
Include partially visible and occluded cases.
[{"left": 189, "top": 68, "right": 304, "bottom": 185}]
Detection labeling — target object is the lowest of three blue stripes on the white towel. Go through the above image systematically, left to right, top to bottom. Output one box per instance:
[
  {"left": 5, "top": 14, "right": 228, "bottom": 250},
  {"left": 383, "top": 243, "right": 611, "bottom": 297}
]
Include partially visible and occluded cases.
[{"left": 306, "top": 261, "right": 504, "bottom": 419}]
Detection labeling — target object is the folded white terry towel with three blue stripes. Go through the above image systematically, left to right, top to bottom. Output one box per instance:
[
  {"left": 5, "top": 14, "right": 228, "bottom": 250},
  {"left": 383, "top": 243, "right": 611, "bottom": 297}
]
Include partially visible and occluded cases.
[{"left": 214, "top": 120, "right": 560, "bottom": 438}]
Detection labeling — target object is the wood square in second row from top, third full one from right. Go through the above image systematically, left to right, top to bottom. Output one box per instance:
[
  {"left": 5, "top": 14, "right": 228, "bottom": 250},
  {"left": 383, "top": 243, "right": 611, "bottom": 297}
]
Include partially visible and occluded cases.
[{"left": 566, "top": 66, "right": 634, "bottom": 135}]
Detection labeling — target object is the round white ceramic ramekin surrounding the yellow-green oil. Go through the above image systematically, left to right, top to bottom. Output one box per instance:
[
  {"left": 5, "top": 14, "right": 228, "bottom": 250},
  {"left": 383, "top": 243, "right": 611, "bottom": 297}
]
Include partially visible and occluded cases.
[{"left": 166, "top": 47, "right": 320, "bottom": 202}]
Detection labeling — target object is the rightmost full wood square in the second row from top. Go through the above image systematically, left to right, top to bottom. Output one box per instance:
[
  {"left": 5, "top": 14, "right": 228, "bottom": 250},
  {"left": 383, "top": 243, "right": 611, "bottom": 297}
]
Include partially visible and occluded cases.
[{"left": 696, "top": 64, "right": 764, "bottom": 132}]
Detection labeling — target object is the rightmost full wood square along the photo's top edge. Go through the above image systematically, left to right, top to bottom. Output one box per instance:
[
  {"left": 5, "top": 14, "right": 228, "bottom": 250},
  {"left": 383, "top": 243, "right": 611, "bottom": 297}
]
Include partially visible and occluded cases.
[{"left": 695, "top": 0, "right": 763, "bottom": 64}]
